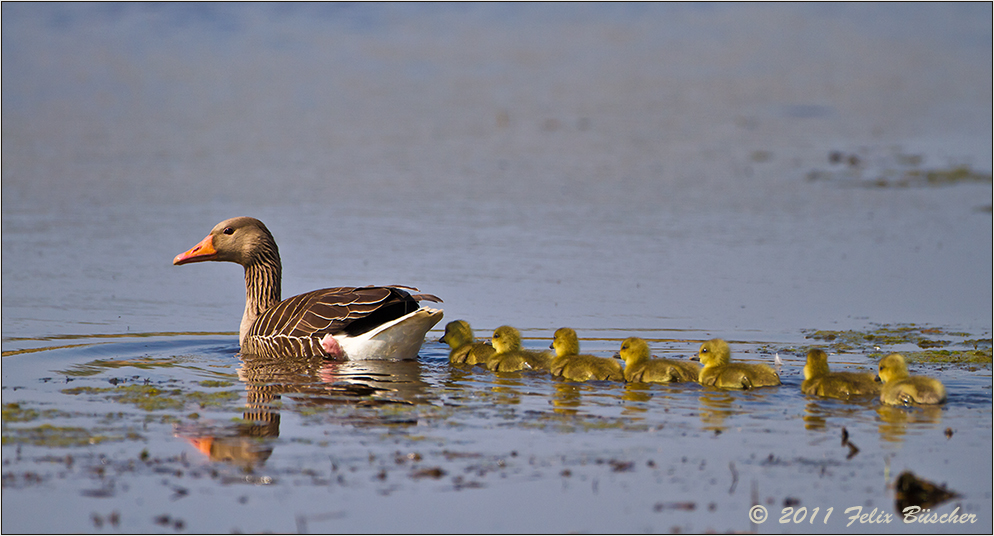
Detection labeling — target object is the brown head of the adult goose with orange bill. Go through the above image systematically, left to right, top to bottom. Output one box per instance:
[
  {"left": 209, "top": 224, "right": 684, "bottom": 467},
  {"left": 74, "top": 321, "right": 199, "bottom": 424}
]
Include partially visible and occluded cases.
[{"left": 173, "top": 216, "right": 279, "bottom": 266}]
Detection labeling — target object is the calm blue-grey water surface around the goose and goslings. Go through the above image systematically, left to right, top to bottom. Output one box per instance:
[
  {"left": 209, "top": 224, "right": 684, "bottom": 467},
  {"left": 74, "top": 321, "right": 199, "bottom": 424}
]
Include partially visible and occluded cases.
[{"left": 2, "top": 3, "right": 994, "bottom": 532}]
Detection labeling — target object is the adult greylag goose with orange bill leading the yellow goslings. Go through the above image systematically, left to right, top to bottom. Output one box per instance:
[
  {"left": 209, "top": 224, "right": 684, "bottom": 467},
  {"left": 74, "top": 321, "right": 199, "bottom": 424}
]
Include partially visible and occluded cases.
[{"left": 173, "top": 217, "right": 442, "bottom": 359}]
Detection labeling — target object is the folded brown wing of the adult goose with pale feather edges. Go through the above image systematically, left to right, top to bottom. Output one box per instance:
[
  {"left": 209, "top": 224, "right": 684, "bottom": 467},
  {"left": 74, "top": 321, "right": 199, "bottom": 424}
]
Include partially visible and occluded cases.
[{"left": 248, "top": 287, "right": 421, "bottom": 338}]
